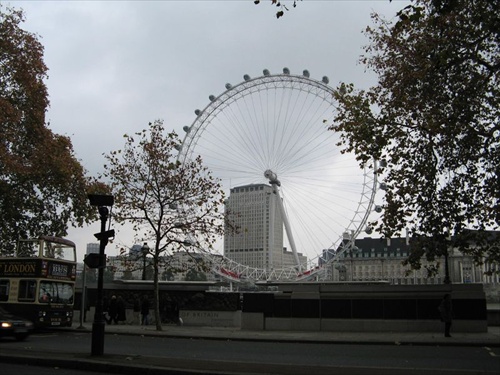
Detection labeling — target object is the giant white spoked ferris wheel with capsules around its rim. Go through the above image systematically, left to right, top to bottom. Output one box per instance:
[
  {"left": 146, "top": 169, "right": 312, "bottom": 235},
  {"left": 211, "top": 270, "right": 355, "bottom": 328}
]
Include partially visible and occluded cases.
[{"left": 178, "top": 68, "right": 380, "bottom": 280}]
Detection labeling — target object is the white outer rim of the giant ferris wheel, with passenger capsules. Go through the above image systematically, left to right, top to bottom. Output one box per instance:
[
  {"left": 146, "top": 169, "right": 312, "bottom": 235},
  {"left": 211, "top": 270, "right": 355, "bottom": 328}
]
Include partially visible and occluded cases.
[{"left": 177, "top": 68, "right": 377, "bottom": 281}]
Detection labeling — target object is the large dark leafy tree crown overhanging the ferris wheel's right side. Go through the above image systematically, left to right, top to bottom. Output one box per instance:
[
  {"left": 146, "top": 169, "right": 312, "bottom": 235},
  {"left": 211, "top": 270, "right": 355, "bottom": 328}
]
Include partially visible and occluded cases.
[{"left": 331, "top": 0, "right": 500, "bottom": 276}]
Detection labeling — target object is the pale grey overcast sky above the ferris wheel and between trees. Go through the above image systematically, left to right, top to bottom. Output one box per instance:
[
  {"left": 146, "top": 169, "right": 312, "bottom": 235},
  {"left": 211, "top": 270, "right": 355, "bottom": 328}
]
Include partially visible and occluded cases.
[{"left": 9, "top": 0, "right": 407, "bottom": 259}]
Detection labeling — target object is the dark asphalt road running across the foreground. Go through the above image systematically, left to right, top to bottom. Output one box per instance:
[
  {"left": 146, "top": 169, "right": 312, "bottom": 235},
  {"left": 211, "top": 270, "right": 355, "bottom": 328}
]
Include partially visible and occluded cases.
[{"left": 0, "top": 331, "right": 500, "bottom": 374}]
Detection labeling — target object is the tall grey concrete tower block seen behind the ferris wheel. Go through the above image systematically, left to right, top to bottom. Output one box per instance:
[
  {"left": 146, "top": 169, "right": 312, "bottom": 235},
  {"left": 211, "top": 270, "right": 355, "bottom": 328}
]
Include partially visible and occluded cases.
[{"left": 224, "top": 184, "right": 284, "bottom": 270}]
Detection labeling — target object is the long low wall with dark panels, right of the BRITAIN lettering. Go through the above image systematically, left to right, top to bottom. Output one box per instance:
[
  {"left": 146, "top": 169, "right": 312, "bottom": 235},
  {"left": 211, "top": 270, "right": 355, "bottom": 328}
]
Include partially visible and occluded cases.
[{"left": 242, "top": 283, "right": 487, "bottom": 332}]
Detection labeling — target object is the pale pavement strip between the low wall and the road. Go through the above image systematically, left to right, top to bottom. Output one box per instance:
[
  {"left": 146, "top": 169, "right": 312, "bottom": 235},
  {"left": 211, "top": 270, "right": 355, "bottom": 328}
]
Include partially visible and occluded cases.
[{"left": 72, "top": 322, "right": 500, "bottom": 347}]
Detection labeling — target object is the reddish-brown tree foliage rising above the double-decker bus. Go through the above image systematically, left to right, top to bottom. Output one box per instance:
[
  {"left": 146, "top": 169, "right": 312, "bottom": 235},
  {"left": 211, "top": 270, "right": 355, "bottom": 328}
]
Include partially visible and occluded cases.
[{"left": 0, "top": 4, "right": 101, "bottom": 253}]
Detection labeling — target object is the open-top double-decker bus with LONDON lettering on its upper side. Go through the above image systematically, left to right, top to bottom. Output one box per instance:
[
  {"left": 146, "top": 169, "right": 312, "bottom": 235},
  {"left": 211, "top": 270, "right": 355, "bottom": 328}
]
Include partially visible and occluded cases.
[{"left": 0, "top": 236, "right": 76, "bottom": 327}]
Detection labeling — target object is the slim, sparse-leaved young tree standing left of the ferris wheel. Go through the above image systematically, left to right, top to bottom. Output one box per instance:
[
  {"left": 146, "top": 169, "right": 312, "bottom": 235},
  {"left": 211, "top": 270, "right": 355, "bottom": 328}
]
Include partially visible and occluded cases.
[{"left": 104, "top": 121, "right": 224, "bottom": 330}]
